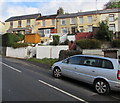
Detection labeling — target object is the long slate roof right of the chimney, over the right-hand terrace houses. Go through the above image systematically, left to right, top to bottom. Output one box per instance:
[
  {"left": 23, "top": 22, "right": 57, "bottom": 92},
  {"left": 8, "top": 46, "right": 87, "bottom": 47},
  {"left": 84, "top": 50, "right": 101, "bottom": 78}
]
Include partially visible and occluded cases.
[{"left": 56, "top": 8, "right": 120, "bottom": 19}]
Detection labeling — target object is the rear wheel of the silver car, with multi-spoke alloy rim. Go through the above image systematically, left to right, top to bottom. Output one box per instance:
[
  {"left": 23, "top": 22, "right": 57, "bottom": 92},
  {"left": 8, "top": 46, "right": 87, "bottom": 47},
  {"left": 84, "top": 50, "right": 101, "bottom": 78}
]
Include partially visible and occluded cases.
[{"left": 94, "top": 80, "right": 110, "bottom": 95}]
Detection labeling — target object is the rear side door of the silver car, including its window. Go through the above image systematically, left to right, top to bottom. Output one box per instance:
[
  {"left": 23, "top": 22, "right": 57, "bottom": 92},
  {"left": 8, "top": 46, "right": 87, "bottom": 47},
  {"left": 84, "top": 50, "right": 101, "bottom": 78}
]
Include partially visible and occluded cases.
[{"left": 76, "top": 57, "right": 98, "bottom": 83}]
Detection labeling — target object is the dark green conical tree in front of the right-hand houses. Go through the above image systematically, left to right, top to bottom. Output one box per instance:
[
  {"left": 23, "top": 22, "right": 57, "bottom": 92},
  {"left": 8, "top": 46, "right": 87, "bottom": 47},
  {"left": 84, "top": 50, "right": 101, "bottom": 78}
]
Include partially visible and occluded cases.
[{"left": 95, "top": 20, "right": 113, "bottom": 41}]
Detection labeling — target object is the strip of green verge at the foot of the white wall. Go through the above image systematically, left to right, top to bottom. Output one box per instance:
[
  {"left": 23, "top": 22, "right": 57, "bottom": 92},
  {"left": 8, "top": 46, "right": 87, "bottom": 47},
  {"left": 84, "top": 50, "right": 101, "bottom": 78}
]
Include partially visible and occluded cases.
[{"left": 28, "top": 58, "right": 58, "bottom": 66}]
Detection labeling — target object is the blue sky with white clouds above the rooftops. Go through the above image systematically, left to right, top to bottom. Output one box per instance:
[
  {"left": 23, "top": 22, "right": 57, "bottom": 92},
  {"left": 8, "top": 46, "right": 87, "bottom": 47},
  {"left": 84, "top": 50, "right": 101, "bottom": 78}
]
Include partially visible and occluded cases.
[{"left": 0, "top": 0, "right": 109, "bottom": 22}]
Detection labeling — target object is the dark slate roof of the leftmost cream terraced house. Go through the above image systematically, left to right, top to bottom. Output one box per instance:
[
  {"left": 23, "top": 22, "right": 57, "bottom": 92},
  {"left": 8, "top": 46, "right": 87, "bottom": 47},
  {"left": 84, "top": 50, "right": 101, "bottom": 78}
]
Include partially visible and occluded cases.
[{"left": 5, "top": 13, "right": 41, "bottom": 22}]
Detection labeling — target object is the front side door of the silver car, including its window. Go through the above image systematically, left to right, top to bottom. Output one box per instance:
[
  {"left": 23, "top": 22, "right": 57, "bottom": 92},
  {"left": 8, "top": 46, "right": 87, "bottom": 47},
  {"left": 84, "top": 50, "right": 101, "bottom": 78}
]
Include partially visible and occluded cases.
[{"left": 61, "top": 56, "right": 80, "bottom": 78}]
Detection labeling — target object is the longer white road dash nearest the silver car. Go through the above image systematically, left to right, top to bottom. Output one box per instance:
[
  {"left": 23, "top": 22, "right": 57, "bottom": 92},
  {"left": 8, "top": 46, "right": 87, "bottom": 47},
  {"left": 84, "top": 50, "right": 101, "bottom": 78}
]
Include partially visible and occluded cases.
[{"left": 38, "top": 80, "right": 88, "bottom": 103}]
